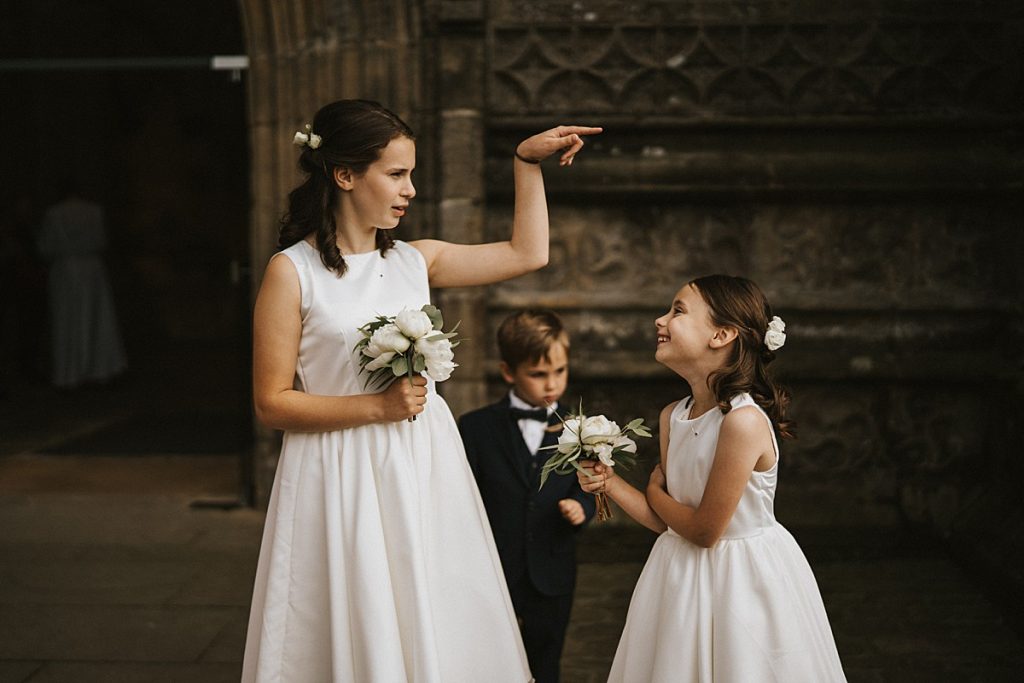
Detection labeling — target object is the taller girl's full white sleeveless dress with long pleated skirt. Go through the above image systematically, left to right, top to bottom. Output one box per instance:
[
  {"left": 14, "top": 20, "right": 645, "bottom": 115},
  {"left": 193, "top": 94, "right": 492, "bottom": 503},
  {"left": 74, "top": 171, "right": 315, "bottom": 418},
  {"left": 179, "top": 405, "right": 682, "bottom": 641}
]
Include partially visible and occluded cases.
[{"left": 242, "top": 241, "right": 530, "bottom": 683}]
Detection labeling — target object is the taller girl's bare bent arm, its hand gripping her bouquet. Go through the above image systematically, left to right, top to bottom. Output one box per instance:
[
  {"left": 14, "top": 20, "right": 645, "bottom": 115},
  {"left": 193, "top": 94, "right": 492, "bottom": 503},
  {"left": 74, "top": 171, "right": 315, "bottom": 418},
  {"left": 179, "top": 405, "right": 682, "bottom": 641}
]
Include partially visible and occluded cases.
[{"left": 253, "top": 256, "right": 426, "bottom": 431}]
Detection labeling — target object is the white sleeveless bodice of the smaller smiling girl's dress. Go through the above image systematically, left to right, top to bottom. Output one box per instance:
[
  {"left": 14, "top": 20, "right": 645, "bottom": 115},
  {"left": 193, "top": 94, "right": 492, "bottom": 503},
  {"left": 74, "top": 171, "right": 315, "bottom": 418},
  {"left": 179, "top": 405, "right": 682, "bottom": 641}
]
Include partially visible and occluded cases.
[{"left": 665, "top": 393, "right": 778, "bottom": 539}]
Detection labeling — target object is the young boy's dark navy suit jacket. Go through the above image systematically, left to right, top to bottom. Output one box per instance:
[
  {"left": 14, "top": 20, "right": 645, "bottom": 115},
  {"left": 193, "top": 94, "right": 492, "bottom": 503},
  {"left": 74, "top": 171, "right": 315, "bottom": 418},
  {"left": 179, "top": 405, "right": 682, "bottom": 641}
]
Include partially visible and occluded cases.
[{"left": 459, "top": 396, "right": 594, "bottom": 595}]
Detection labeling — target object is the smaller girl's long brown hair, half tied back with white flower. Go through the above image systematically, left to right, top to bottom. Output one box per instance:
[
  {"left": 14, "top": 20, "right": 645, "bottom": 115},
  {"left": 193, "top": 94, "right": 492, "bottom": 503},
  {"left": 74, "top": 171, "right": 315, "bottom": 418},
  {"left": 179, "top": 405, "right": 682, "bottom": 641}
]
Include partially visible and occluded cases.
[{"left": 690, "top": 275, "right": 796, "bottom": 438}]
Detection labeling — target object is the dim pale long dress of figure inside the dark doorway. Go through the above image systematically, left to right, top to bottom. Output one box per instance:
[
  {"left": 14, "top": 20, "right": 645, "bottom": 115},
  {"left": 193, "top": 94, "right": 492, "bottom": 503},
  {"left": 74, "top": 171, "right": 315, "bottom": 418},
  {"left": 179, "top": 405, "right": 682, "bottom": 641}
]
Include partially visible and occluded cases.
[{"left": 37, "top": 198, "right": 127, "bottom": 388}]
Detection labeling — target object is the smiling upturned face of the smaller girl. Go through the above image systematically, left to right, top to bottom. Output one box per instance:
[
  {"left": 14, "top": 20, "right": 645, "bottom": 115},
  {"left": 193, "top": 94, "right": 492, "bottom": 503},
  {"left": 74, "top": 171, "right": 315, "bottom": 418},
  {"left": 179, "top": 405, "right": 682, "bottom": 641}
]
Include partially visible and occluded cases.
[{"left": 654, "top": 285, "right": 718, "bottom": 372}]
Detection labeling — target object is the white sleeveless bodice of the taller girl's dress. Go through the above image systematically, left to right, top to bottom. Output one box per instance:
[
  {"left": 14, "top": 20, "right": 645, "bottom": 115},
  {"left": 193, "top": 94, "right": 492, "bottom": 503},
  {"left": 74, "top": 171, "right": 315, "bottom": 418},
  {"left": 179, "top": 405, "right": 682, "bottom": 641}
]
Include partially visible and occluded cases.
[{"left": 281, "top": 240, "right": 433, "bottom": 396}]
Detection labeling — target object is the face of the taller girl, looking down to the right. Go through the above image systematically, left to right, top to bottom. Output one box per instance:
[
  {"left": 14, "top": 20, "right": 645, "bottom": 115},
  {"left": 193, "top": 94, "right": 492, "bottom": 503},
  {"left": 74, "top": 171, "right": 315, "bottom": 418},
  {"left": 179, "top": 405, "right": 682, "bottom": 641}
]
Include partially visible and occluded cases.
[{"left": 348, "top": 136, "right": 416, "bottom": 229}]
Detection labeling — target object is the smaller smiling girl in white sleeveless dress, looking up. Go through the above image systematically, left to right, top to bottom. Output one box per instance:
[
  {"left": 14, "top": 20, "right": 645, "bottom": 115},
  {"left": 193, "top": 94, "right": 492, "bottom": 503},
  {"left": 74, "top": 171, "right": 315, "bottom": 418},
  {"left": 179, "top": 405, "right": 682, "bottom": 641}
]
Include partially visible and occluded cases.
[{"left": 580, "top": 275, "right": 846, "bottom": 683}]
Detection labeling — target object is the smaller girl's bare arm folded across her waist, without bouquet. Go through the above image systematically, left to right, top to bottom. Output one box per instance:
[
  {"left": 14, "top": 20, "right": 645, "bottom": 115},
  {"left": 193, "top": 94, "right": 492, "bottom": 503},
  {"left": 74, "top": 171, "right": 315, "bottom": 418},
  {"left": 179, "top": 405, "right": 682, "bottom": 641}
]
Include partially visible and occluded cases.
[{"left": 647, "top": 407, "right": 776, "bottom": 548}]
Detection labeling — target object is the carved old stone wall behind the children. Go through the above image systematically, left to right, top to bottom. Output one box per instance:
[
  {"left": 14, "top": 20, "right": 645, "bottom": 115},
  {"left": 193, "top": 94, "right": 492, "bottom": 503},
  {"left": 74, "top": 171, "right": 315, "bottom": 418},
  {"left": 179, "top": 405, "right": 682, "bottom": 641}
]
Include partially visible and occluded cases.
[{"left": 243, "top": 0, "right": 1024, "bottom": 589}]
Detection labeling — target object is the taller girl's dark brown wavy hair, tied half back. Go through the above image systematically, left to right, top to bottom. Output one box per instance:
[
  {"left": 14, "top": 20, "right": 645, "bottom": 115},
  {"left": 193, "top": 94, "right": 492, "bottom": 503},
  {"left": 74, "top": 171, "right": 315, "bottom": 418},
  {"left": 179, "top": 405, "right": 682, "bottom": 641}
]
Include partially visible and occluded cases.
[{"left": 278, "top": 99, "right": 416, "bottom": 276}]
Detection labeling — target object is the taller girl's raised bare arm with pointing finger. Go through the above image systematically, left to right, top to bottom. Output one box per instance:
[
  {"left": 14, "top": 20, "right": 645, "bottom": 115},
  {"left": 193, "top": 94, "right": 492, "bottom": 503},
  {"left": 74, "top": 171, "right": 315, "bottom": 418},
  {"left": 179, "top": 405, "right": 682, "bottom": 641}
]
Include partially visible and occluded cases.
[{"left": 412, "top": 126, "right": 601, "bottom": 287}]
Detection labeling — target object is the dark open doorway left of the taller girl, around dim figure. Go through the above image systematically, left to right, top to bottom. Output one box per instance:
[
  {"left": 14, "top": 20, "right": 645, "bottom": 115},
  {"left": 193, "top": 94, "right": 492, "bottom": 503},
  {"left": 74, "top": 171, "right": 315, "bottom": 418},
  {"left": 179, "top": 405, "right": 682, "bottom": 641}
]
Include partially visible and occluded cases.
[{"left": 0, "top": 0, "right": 251, "bottom": 499}]
